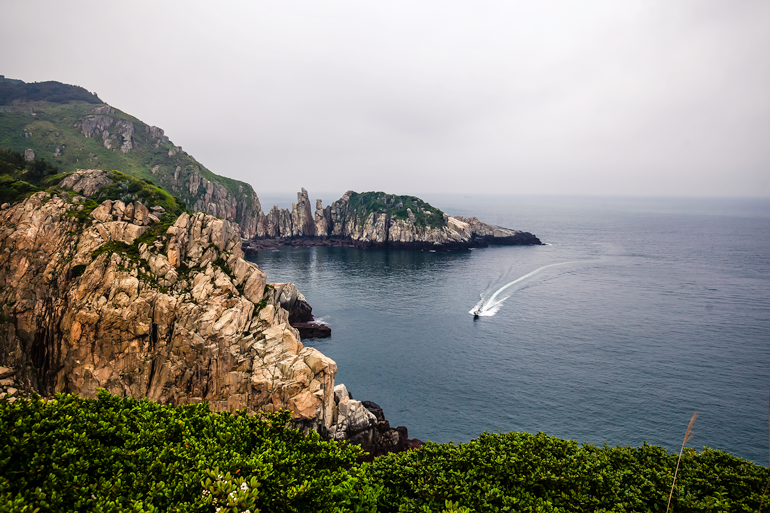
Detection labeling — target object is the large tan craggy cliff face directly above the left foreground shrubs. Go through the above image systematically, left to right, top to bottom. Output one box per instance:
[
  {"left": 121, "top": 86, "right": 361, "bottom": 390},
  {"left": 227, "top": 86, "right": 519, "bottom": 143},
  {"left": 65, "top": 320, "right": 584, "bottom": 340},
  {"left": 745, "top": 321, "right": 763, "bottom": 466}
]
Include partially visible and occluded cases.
[{"left": 0, "top": 171, "right": 337, "bottom": 432}]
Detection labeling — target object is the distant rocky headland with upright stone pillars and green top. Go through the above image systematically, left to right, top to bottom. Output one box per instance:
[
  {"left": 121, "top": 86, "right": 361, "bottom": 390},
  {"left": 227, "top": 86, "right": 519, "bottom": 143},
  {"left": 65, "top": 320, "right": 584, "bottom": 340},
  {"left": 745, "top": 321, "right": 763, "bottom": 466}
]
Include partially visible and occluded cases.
[{"left": 247, "top": 188, "right": 541, "bottom": 249}]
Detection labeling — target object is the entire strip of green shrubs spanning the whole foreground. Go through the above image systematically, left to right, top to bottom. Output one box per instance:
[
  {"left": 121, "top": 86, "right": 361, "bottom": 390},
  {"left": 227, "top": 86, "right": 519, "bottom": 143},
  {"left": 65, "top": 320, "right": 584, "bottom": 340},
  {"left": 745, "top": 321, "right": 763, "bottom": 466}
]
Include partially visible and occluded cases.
[{"left": 0, "top": 392, "right": 770, "bottom": 513}]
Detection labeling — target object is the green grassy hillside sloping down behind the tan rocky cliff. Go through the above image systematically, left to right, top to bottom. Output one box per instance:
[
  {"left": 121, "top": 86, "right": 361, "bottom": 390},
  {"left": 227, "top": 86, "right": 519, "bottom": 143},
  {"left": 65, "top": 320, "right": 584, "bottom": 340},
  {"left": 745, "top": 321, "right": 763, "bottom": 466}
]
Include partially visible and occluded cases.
[{"left": 0, "top": 82, "right": 254, "bottom": 219}]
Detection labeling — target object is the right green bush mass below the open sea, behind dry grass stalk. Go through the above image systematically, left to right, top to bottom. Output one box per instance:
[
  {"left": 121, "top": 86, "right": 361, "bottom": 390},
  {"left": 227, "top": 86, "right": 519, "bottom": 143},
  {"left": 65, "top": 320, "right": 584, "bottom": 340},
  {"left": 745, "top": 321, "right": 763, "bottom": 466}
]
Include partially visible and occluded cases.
[{"left": 358, "top": 433, "right": 768, "bottom": 513}]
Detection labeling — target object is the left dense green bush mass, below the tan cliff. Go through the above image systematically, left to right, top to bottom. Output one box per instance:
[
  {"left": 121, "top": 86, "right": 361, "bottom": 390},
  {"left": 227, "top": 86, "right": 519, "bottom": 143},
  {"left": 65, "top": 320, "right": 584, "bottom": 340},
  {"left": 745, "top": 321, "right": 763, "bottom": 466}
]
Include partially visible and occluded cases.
[{"left": 0, "top": 391, "right": 361, "bottom": 512}]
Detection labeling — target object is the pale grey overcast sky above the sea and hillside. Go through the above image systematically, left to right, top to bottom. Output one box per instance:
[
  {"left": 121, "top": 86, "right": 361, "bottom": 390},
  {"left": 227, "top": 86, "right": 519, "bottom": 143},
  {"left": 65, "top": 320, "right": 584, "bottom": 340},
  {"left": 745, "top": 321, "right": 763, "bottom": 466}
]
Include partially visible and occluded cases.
[{"left": 0, "top": 0, "right": 770, "bottom": 199}]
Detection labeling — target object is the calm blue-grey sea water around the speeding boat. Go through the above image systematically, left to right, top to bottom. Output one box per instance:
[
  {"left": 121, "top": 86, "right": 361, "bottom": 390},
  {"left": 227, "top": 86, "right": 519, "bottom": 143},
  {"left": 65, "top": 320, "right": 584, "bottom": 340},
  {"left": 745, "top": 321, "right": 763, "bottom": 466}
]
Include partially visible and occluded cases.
[{"left": 254, "top": 195, "right": 770, "bottom": 465}]
